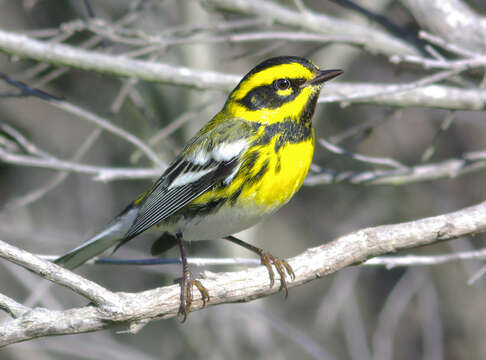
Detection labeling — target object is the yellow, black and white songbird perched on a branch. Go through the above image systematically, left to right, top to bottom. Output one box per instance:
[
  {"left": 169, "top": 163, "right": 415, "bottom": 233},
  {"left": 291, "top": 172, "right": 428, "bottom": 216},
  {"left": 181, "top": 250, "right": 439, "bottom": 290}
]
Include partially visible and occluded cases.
[{"left": 54, "top": 56, "right": 343, "bottom": 322}]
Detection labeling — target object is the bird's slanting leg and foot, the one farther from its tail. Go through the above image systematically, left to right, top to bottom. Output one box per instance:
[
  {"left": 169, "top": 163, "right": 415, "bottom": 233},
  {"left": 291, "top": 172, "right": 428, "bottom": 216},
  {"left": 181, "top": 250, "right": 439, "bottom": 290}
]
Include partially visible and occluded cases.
[{"left": 225, "top": 236, "right": 295, "bottom": 298}]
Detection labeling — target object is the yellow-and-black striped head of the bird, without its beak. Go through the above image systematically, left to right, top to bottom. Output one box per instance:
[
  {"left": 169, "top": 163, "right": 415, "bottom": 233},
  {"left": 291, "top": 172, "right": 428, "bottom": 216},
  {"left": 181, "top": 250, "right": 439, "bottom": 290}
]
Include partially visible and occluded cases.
[{"left": 225, "top": 58, "right": 322, "bottom": 124}]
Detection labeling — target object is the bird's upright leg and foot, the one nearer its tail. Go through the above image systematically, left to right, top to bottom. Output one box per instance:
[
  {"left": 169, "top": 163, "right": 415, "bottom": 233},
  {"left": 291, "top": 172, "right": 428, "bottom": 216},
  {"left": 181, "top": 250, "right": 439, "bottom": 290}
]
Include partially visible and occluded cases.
[{"left": 176, "top": 232, "right": 209, "bottom": 322}]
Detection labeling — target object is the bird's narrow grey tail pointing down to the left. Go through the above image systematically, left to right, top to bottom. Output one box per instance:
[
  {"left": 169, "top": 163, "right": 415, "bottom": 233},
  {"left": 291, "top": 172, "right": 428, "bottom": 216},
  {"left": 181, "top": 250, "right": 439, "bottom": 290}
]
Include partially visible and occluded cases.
[{"left": 54, "top": 207, "right": 138, "bottom": 269}]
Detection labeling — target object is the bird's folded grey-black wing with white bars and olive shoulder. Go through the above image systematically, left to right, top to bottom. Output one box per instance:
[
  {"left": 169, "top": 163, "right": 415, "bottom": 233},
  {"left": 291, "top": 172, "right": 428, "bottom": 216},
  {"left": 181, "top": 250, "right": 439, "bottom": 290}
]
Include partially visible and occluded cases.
[{"left": 124, "top": 121, "right": 252, "bottom": 241}]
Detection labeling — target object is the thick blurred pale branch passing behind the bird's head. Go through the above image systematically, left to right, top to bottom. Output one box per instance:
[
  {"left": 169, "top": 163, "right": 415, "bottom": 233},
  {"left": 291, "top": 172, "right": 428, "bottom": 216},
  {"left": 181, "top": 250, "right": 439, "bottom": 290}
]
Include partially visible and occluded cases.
[{"left": 0, "top": 30, "right": 486, "bottom": 110}]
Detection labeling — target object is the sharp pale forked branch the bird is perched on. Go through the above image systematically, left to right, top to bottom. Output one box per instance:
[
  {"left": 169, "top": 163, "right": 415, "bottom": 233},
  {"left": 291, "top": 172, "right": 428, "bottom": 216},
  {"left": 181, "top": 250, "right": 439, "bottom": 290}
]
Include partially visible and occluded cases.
[{"left": 0, "top": 202, "right": 486, "bottom": 346}]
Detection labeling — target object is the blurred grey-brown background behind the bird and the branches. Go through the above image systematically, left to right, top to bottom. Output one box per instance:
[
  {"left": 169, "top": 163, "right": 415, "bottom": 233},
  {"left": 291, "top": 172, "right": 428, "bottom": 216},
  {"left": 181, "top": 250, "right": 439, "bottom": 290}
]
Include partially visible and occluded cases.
[{"left": 0, "top": 0, "right": 486, "bottom": 360}]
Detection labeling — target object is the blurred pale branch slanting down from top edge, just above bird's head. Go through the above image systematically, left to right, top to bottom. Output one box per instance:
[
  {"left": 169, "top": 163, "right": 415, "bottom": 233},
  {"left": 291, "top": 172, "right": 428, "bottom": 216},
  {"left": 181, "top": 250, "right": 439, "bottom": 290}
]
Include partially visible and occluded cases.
[{"left": 202, "top": 0, "right": 419, "bottom": 55}]
